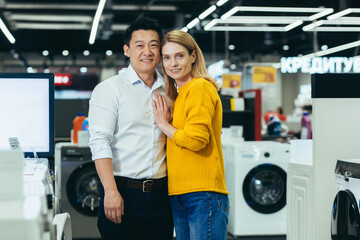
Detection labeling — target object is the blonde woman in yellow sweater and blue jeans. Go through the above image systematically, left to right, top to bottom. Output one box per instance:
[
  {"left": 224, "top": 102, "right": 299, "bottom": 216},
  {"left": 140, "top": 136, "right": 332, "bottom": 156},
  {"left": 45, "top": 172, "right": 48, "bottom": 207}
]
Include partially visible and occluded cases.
[{"left": 153, "top": 30, "right": 229, "bottom": 240}]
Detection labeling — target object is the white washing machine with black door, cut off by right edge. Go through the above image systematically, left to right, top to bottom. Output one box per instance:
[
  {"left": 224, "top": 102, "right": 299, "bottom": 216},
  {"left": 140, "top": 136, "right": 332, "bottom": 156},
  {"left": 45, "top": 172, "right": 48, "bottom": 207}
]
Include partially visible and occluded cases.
[{"left": 331, "top": 159, "right": 360, "bottom": 240}]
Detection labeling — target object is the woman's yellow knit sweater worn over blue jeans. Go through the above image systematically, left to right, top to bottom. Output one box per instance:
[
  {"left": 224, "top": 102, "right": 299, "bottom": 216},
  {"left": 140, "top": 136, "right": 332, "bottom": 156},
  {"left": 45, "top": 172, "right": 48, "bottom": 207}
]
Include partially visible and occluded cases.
[{"left": 167, "top": 78, "right": 229, "bottom": 195}]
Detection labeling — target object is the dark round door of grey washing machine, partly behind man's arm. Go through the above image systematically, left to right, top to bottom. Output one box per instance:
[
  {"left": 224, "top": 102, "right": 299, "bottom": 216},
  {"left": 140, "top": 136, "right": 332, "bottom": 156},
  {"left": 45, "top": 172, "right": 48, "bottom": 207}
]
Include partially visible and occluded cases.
[{"left": 66, "top": 161, "right": 101, "bottom": 216}]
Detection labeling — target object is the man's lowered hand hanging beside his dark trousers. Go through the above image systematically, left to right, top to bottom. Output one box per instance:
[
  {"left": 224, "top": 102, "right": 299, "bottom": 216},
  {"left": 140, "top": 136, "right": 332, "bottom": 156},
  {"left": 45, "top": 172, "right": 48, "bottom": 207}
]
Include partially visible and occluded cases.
[{"left": 104, "top": 190, "right": 124, "bottom": 223}]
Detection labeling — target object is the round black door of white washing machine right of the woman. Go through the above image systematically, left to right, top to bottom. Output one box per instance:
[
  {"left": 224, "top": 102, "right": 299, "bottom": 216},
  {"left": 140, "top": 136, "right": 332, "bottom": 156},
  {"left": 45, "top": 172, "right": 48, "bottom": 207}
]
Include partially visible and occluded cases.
[{"left": 243, "top": 164, "right": 286, "bottom": 214}]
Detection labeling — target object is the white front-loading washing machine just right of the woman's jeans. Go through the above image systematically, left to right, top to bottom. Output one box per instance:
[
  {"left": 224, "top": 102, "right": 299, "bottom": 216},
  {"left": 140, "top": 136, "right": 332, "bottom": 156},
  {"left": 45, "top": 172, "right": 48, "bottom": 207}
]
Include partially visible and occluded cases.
[{"left": 223, "top": 139, "right": 290, "bottom": 236}]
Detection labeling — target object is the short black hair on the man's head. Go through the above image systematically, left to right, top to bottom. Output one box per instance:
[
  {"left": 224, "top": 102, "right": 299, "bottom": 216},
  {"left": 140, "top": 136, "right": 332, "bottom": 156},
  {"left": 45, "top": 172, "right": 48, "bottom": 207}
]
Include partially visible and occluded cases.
[{"left": 124, "top": 17, "right": 163, "bottom": 46}]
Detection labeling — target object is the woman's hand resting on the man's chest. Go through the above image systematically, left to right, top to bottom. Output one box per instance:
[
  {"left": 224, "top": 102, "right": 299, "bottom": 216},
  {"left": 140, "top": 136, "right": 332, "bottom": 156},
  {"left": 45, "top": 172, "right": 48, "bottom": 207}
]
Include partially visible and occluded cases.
[{"left": 152, "top": 93, "right": 177, "bottom": 139}]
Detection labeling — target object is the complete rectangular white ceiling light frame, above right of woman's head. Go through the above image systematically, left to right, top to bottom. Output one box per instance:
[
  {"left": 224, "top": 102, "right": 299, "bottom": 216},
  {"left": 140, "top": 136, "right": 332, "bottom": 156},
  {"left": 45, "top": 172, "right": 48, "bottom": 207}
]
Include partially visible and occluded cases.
[{"left": 204, "top": 6, "right": 334, "bottom": 32}]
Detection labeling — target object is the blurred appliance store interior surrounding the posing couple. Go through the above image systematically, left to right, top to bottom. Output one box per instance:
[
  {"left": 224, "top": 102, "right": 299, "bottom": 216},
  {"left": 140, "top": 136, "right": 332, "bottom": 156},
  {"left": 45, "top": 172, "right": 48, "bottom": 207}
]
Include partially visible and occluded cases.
[{"left": 0, "top": 0, "right": 360, "bottom": 240}]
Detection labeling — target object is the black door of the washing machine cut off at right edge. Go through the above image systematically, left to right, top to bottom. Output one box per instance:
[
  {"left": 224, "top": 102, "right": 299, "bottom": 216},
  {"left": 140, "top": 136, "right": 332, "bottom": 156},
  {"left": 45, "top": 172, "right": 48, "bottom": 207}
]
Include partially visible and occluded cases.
[{"left": 331, "top": 190, "right": 360, "bottom": 240}]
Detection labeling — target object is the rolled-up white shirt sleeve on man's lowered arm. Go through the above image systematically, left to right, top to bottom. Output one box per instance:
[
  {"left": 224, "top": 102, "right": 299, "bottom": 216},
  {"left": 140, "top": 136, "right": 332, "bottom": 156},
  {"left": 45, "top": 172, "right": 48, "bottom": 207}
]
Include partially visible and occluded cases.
[{"left": 88, "top": 82, "right": 118, "bottom": 160}]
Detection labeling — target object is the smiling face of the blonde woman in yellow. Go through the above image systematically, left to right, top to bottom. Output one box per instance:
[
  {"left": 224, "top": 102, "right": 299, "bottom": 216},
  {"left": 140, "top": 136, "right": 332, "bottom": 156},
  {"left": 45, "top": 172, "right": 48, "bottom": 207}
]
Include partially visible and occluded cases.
[{"left": 161, "top": 42, "right": 196, "bottom": 87}]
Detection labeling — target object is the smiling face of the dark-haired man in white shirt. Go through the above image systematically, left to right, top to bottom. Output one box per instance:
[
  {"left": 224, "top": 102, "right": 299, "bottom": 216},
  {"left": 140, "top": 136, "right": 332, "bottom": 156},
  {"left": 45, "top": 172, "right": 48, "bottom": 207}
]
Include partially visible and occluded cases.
[{"left": 124, "top": 30, "right": 160, "bottom": 74}]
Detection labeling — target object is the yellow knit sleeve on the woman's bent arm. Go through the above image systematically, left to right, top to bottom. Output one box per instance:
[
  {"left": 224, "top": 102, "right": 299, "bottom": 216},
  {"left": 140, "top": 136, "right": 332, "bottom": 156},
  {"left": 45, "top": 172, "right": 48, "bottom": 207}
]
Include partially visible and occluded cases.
[{"left": 173, "top": 86, "right": 215, "bottom": 152}]
